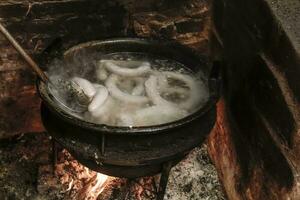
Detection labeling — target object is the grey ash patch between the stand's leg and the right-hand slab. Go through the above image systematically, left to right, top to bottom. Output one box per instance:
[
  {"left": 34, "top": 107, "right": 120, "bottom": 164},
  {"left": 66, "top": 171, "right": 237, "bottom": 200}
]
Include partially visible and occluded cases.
[{"left": 165, "top": 144, "right": 225, "bottom": 200}]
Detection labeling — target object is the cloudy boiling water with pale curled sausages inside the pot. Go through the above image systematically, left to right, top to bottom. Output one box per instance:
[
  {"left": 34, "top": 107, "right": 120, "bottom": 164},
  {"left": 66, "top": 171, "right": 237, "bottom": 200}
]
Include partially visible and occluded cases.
[{"left": 49, "top": 53, "right": 209, "bottom": 127}]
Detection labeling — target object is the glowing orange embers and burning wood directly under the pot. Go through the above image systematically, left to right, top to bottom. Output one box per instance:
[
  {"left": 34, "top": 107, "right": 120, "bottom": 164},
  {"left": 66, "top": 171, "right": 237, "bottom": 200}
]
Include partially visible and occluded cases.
[{"left": 55, "top": 150, "right": 164, "bottom": 200}]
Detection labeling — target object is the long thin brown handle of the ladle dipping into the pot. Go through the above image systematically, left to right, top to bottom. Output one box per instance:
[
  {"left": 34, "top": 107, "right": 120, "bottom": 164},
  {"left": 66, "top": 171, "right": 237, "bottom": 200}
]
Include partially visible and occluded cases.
[{"left": 0, "top": 23, "right": 49, "bottom": 83}]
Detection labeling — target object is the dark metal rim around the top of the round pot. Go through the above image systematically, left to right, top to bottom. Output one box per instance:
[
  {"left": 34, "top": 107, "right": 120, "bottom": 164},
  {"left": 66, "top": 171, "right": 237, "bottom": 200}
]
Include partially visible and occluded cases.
[{"left": 36, "top": 38, "right": 218, "bottom": 135}]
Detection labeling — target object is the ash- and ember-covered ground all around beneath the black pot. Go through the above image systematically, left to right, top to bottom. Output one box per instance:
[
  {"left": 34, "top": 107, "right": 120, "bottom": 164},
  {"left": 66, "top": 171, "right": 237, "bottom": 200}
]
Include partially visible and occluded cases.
[{"left": 0, "top": 134, "right": 225, "bottom": 200}]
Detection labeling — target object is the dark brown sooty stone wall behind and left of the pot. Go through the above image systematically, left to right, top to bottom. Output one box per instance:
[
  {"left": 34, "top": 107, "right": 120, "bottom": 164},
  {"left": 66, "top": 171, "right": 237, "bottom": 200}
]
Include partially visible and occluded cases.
[{"left": 0, "top": 0, "right": 210, "bottom": 138}]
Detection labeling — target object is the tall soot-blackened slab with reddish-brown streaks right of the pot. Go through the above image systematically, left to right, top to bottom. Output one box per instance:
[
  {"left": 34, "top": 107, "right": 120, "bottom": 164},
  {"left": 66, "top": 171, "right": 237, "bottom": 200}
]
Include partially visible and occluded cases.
[{"left": 208, "top": 0, "right": 300, "bottom": 200}]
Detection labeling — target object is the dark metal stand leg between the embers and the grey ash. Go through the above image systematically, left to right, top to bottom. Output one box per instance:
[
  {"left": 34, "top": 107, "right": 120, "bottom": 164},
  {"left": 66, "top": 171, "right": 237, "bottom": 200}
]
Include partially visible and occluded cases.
[{"left": 157, "top": 161, "right": 173, "bottom": 200}]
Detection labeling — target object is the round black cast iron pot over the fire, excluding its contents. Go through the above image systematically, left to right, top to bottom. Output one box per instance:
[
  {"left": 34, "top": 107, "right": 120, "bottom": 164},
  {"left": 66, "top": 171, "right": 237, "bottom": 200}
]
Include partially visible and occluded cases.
[{"left": 37, "top": 38, "right": 220, "bottom": 178}]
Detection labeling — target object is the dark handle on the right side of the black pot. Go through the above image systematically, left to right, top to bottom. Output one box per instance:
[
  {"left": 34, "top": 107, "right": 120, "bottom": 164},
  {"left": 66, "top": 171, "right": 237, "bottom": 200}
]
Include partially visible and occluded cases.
[{"left": 208, "top": 61, "right": 222, "bottom": 101}]
